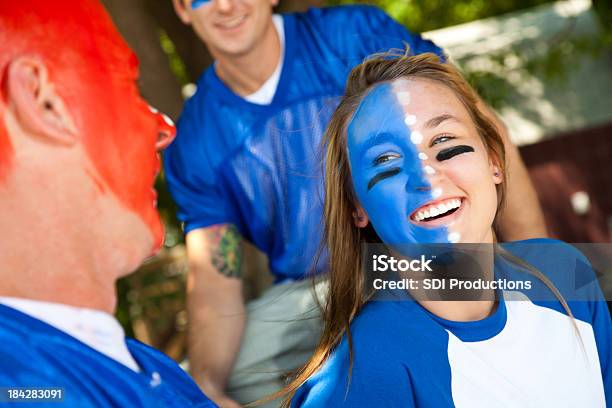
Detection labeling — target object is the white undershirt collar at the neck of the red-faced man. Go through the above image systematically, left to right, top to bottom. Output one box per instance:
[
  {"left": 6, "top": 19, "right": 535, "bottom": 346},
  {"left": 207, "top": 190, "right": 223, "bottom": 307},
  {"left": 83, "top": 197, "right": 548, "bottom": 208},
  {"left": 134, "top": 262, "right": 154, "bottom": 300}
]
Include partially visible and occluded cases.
[{"left": 0, "top": 297, "right": 140, "bottom": 372}]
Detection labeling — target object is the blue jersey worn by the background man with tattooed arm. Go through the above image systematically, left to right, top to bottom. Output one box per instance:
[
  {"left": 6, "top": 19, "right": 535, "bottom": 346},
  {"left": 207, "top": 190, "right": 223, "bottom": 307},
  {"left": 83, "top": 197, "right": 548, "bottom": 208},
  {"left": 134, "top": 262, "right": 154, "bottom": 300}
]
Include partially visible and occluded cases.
[{"left": 164, "top": 6, "right": 442, "bottom": 281}]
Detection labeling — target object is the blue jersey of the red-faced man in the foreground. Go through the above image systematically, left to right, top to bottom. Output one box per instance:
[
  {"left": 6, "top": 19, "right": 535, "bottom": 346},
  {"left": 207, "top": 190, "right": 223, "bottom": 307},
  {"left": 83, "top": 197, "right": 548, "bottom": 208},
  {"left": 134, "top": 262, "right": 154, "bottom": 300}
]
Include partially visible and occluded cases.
[{"left": 0, "top": 305, "right": 216, "bottom": 408}]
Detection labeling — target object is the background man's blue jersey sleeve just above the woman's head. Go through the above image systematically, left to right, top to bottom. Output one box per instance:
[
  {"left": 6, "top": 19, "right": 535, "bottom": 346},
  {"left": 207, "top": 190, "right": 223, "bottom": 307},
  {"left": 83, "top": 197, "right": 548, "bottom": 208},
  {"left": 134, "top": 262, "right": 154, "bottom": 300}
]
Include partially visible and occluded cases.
[{"left": 310, "top": 6, "right": 445, "bottom": 62}]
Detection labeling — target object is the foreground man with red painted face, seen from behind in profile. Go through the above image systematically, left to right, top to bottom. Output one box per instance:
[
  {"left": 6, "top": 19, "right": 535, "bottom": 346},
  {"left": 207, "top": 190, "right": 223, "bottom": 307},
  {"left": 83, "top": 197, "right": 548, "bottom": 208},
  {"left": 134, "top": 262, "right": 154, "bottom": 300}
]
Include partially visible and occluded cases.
[{"left": 0, "top": 0, "right": 214, "bottom": 407}]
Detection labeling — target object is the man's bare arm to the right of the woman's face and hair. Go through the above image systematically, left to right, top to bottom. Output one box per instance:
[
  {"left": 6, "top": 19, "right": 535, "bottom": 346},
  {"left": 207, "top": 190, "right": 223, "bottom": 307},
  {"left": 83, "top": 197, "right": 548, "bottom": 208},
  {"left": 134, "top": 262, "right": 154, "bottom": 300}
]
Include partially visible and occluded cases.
[{"left": 479, "top": 100, "right": 547, "bottom": 241}]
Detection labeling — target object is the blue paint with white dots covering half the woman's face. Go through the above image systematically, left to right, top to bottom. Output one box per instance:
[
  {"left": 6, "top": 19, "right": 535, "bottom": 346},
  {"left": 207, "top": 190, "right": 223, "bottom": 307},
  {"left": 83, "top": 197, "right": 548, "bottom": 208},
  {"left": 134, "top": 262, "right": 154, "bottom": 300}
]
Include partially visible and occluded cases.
[{"left": 348, "top": 83, "right": 453, "bottom": 244}]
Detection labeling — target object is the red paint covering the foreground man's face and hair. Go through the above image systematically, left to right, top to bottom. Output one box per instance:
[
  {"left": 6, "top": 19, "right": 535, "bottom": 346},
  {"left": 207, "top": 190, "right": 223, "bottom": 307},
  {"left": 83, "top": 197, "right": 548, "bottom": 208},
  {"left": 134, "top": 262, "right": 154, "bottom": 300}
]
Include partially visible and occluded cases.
[{"left": 0, "top": 0, "right": 174, "bottom": 252}]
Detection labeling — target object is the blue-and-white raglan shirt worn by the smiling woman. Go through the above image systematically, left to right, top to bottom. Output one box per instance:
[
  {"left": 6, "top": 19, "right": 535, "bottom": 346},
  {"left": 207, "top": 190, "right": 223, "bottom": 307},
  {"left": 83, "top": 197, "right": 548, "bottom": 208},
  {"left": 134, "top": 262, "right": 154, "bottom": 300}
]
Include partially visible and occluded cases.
[{"left": 292, "top": 240, "right": 612, "bottom": 408}]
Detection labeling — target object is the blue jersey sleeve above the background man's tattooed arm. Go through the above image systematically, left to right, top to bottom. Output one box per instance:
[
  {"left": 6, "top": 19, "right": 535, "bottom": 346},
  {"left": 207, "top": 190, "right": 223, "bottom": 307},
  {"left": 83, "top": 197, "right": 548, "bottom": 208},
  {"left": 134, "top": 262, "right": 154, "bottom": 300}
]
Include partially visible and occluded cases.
[{"left": 164, "top": 93, "right": 230, "bottom": 233}]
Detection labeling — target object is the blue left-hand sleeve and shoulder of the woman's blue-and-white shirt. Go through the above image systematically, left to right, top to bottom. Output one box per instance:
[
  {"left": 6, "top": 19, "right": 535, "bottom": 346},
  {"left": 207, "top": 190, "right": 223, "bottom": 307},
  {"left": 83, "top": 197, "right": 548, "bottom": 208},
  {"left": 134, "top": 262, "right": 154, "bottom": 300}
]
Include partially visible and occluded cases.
[{"left": 292, "top": 301, "right": 447, "bottom": 407}]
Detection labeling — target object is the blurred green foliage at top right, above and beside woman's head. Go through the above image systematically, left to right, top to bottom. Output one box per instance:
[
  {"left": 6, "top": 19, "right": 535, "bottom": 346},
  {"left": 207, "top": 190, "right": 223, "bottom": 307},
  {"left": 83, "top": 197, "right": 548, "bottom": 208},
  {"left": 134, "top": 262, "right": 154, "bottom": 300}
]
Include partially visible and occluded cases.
[{"left": 326, "top": 0, "right": 612, "bottom": 109}]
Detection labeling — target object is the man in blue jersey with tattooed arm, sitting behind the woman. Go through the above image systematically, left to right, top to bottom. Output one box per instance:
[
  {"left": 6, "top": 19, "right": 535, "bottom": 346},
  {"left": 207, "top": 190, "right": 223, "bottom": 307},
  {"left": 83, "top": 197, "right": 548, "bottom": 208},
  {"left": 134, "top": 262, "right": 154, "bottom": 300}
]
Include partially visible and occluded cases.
[{"left": 164, "top": 0, "right": 545, "bottom": 406}]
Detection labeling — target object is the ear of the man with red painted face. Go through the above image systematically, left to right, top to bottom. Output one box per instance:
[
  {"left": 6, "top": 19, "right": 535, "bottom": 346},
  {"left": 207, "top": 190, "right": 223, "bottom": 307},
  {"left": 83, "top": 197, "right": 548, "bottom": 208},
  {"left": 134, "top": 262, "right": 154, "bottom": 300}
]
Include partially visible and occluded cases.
[{"left": 6, "top": 56, "right": 77, "bottom": 145}]
